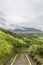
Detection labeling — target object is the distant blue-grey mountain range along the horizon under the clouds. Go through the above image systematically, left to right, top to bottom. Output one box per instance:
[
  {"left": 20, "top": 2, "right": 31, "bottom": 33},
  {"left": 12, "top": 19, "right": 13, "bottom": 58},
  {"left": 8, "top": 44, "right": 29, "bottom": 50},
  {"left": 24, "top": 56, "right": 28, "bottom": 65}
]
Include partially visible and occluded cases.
[{"left": 9, "top": 27, "right": 42, "bottom": 32}]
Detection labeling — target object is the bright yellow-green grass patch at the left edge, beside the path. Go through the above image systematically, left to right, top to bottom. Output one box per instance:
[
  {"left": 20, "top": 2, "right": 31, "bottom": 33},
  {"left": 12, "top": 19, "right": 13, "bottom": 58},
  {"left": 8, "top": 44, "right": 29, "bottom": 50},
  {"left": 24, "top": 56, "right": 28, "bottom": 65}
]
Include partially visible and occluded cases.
[{"left": 0, "top": 31, "right": 13, "bottom": 65}]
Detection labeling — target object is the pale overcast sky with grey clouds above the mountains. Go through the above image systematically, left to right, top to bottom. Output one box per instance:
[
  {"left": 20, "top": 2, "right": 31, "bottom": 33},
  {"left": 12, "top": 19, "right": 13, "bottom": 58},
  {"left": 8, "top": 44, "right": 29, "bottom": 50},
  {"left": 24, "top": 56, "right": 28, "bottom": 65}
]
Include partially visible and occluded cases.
[{"left": 0, "top": 0, "right": 43, "bottom": 30}]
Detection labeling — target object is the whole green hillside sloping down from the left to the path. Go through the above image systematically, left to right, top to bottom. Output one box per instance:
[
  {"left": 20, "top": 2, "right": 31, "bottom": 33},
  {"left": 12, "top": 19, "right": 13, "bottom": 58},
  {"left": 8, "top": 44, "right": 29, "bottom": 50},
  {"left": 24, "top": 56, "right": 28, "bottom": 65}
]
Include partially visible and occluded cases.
[{"left": 0, "top": 29, "right": 25, "bottom": 65}]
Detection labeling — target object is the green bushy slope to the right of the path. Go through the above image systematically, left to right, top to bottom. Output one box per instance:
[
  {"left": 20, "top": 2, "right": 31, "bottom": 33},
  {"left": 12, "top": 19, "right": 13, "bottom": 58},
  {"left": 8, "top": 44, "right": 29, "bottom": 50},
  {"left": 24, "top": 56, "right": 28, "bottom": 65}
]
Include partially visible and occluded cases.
[{"left": 24, "top": 37, "right": 43, "bottom": 65}]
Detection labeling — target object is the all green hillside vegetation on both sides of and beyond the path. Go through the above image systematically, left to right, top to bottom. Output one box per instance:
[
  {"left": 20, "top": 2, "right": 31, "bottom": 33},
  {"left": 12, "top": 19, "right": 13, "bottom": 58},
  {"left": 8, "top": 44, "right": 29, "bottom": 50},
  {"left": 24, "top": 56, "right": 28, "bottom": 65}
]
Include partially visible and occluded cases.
[{"left": 0, "top": 28, "right": 43, "bottom": 65}]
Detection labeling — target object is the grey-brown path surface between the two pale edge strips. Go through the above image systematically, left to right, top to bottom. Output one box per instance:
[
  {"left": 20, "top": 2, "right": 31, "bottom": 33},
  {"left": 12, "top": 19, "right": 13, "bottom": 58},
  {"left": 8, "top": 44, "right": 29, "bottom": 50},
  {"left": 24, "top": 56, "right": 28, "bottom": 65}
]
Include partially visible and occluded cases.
[{"left": 13, "top": 54, "right": 28, "bottom": 65}]
